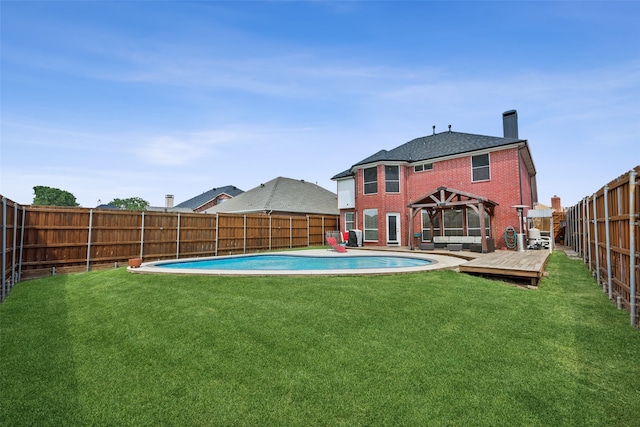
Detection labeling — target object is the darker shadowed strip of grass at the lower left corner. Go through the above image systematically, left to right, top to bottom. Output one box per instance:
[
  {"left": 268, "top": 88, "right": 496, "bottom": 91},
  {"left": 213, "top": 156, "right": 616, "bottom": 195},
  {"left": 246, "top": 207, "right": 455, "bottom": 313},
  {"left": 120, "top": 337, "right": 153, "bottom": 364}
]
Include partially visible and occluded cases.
[{"left": 0, "top": 275, "right": 88, "bottom": 426}]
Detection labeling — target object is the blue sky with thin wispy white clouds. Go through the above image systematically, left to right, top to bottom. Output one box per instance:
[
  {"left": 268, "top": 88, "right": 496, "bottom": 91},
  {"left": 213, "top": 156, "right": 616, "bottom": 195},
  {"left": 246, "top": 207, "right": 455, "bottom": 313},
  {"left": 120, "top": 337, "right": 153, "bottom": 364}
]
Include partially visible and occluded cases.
[{"left": 0, "top": 0, "right": 640, "bottom": 207}]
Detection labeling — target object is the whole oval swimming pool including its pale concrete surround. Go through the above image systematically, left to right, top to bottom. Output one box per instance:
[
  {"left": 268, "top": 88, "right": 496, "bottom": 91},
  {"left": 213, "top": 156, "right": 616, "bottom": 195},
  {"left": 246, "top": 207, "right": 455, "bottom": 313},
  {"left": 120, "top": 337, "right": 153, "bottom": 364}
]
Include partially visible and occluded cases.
[{"left": 129, "top": 249, "right": 464, "bottom": 276}]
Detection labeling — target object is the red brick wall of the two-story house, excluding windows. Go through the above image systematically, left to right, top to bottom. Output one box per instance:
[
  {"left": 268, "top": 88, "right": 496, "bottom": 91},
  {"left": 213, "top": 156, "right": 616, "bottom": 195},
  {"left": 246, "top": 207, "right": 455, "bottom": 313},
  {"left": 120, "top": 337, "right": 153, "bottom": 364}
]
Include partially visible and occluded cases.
[{"left": 342, "top": 148, "right": 532, "bottom": 248}]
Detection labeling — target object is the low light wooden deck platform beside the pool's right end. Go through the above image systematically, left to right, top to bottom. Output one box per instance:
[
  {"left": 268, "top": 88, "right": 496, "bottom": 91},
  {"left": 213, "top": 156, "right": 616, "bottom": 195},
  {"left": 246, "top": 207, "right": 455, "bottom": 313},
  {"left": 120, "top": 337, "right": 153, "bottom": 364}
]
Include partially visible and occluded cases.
[{"left": 459, "top": 250, "right": 550, "bottom": 286}]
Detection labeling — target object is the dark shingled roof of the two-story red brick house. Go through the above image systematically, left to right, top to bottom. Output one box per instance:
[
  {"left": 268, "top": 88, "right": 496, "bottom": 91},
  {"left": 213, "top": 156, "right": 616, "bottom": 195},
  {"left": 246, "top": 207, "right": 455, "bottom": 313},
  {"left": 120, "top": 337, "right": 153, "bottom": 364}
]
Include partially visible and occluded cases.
[{"left": 331, "top": 131, "right": 535, "bottom": 179}]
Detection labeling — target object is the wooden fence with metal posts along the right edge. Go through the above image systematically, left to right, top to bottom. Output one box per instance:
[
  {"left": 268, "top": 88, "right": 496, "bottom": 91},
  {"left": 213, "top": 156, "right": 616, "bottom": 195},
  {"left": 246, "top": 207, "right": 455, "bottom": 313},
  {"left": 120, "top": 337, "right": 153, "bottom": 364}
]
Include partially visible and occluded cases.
[{"left": 566, "top": 166, "right": 640, "bottom": 326}]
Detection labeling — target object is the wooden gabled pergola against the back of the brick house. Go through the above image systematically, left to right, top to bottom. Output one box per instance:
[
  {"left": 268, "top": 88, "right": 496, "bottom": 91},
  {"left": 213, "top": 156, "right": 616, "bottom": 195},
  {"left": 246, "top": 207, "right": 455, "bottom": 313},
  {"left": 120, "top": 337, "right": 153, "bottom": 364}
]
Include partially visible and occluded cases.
[{"left": 409, "top": 187, "right": 498, "bottom": 253}]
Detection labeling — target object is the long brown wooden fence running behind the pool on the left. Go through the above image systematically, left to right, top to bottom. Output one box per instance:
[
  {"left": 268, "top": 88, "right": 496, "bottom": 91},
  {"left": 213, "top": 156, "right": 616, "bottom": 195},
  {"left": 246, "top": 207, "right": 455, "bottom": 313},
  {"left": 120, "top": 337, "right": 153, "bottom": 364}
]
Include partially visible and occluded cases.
[{"left": 2, "top": 197, "right": 338, "bottom": 300}]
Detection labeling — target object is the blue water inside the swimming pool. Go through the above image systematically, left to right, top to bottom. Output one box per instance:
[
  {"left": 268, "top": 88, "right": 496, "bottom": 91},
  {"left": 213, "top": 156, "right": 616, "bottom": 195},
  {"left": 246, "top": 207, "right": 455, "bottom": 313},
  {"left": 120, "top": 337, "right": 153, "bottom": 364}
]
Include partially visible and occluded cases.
[{"left": 156, "top": 255, "right": 431, "bottom": 270}]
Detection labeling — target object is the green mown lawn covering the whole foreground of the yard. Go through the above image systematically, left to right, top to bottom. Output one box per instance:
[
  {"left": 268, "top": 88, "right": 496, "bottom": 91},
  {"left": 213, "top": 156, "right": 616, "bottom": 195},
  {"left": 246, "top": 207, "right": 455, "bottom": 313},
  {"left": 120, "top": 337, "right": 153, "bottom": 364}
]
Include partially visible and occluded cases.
[{"left": 0, "top": 253, "right": 640, "bottom": 426}]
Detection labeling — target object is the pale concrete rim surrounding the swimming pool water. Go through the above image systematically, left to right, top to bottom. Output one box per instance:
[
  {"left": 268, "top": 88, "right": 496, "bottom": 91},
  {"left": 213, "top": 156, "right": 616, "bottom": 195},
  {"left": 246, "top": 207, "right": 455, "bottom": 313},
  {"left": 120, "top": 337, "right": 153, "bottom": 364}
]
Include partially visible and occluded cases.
[{"left": 128, "top": 248, "right": 466, "bottom": 276}]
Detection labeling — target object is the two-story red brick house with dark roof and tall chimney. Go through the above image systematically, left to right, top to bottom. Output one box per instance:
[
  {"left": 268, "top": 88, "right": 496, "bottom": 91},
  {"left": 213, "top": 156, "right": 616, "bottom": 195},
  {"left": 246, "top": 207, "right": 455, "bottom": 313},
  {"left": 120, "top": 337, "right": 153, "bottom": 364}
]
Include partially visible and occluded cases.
[{"left": 331, "top": 110, "right": 538, "bottom": 248}]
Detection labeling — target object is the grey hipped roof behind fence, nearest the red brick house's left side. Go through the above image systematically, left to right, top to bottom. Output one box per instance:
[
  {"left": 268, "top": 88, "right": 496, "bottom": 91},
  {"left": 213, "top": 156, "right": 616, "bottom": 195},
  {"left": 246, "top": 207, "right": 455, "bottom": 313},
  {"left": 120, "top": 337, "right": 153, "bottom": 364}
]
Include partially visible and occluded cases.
[{"left": 205, "top": 176, "right": 340, "bottom": 215}]
